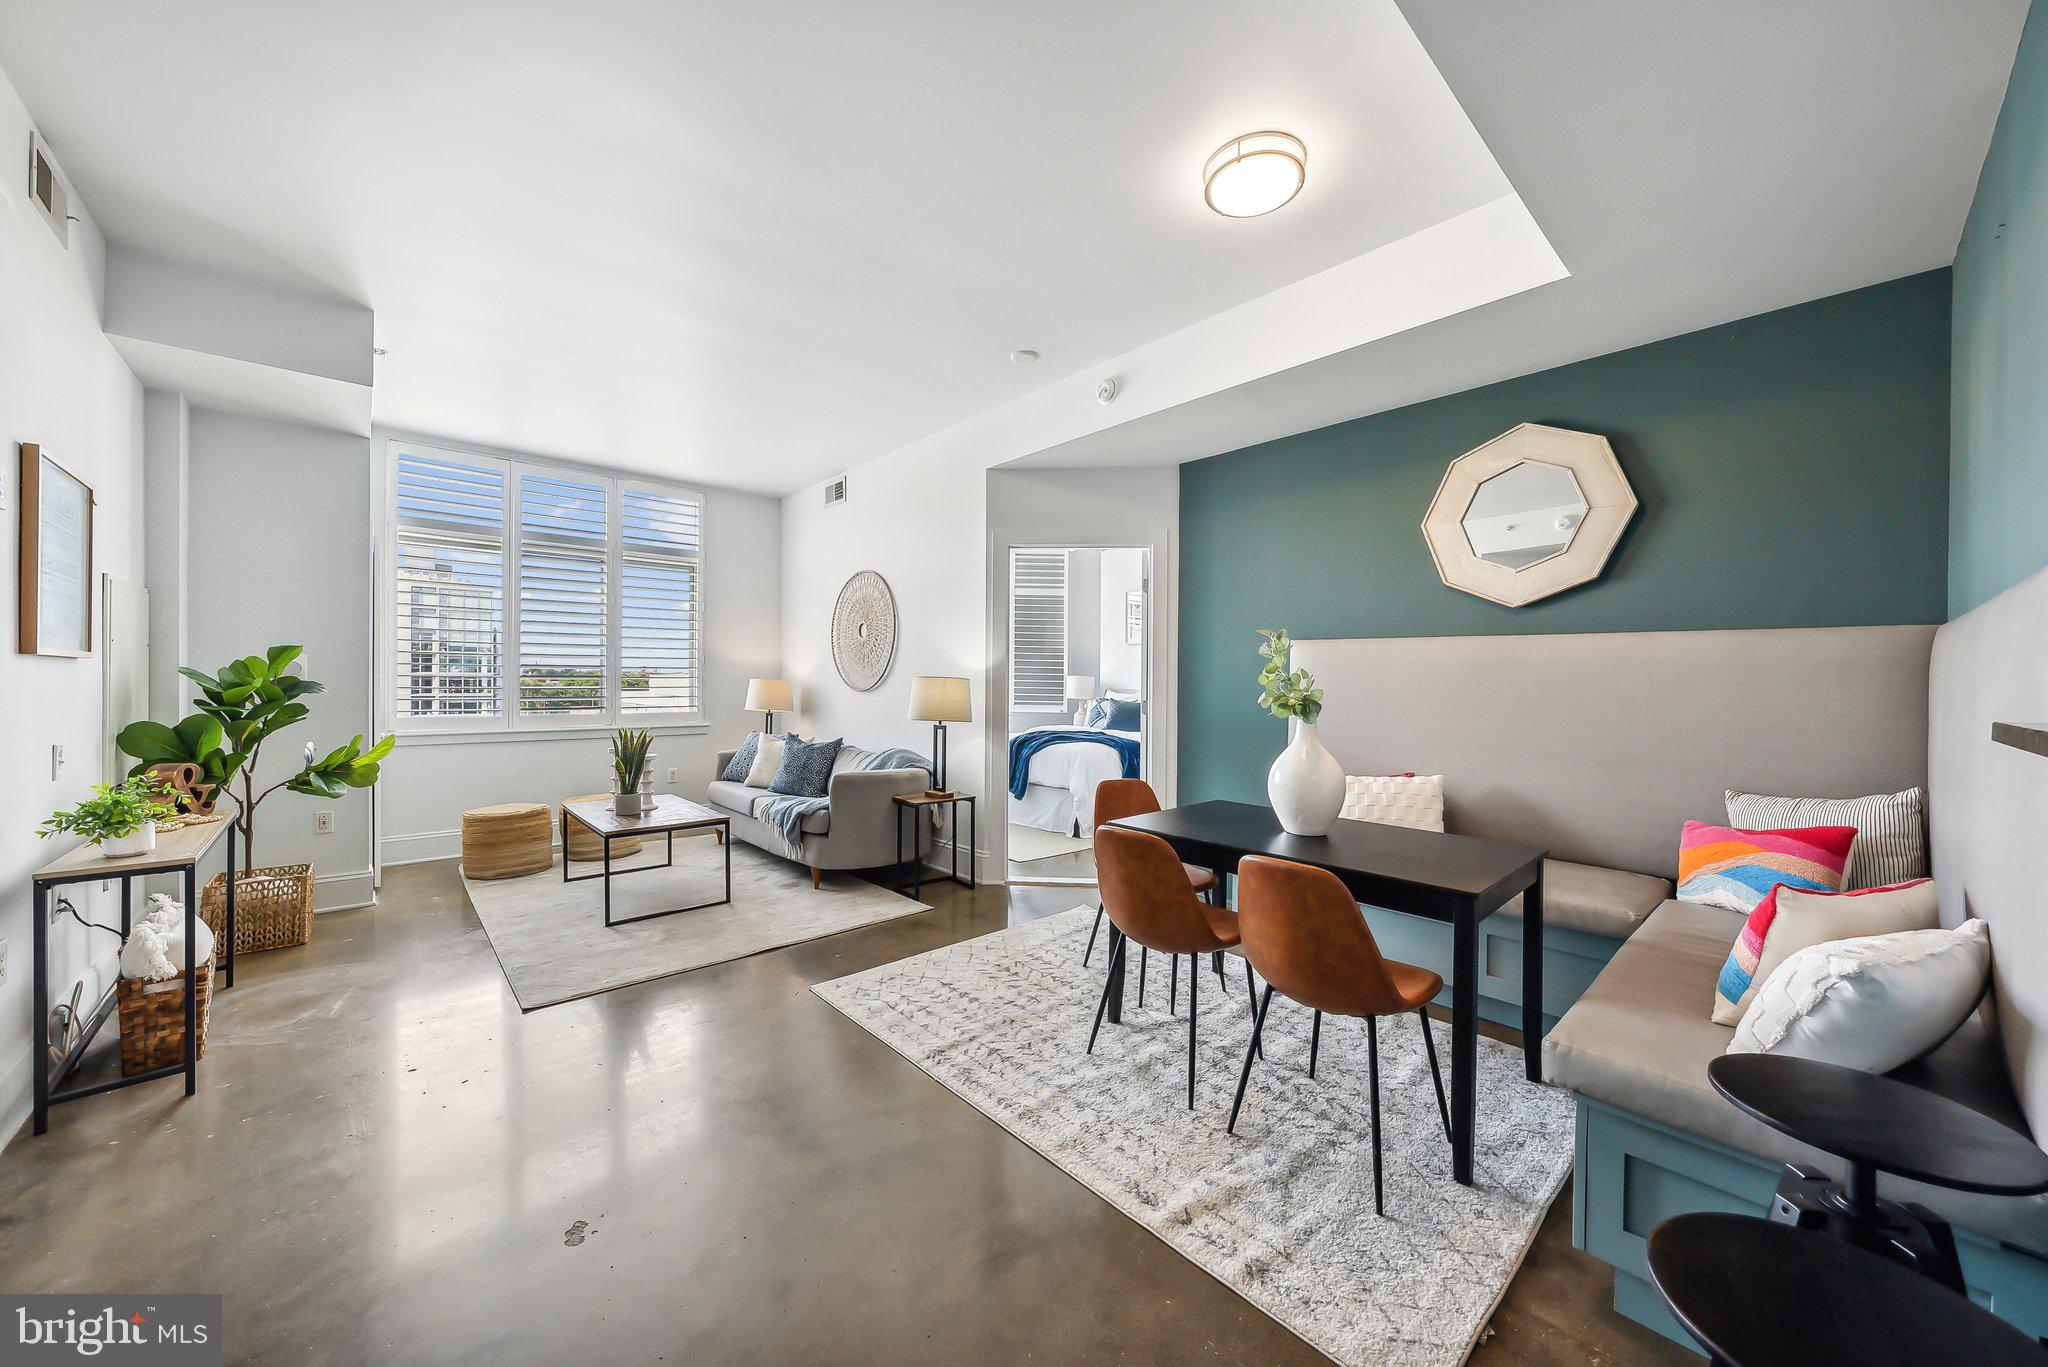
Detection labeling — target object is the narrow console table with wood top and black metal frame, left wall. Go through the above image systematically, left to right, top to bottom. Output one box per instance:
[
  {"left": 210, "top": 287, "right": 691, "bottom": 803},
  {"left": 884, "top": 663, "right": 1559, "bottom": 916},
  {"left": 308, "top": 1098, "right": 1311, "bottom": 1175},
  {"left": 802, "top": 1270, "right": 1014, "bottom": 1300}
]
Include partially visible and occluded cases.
[{"left": 29, "top": 820, "right": 236, "bottom": 1133}]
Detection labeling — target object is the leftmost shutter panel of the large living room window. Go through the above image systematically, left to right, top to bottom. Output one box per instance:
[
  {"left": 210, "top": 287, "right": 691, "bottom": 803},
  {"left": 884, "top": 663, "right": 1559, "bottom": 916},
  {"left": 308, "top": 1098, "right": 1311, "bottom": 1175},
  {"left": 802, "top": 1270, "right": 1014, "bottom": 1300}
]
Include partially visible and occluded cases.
[{"left": 391, "top": 451, "right": 506, "bottom": 719}]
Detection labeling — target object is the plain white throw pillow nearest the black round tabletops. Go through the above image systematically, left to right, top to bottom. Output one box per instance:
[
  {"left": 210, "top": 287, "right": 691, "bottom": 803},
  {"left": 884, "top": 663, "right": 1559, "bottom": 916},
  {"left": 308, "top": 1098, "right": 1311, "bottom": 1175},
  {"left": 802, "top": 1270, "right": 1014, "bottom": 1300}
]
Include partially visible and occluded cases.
[{"left": 1729, "top": 920, "right": 1991, "bottom": 1072}]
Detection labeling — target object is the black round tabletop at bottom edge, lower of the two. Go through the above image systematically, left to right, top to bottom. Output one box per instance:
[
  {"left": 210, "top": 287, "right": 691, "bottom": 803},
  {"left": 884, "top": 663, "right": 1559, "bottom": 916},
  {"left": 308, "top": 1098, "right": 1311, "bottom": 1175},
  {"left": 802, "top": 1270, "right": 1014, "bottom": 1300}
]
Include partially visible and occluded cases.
[{"left": 1649, "top": 1211, "right": 2048, "bottom": 1367}]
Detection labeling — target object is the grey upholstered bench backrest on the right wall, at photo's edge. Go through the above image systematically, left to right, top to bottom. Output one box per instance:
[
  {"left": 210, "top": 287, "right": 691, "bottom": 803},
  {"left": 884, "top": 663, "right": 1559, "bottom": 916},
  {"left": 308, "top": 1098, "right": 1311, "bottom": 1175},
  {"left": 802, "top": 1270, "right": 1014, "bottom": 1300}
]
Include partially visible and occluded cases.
[{"left": 1927, "top": 570, "right": 2048, "bottom": 1140}]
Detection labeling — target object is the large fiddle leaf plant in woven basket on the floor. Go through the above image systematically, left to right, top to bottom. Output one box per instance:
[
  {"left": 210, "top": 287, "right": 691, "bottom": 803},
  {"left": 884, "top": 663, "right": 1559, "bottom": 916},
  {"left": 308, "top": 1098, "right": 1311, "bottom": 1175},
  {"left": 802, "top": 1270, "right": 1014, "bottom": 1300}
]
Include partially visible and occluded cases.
[{"left": 115, "top": 646, "right": 397, "bottom": 953}]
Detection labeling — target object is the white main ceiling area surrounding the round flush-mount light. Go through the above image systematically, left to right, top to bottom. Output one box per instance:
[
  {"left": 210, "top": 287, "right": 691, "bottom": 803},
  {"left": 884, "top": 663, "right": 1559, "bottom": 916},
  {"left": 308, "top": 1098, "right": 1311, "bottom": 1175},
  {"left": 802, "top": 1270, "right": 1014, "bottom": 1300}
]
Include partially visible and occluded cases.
[{"left": 0, "top": 0, "right": 1523, "bottom": 492}]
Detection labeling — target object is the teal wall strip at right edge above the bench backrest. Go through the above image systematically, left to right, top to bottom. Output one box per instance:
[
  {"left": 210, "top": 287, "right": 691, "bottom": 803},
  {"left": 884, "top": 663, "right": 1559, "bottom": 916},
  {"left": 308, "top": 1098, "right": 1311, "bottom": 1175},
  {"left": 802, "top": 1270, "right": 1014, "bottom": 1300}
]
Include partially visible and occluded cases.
[{"left": 1948, "top": 4, "right": 2048, "bottom": 617}]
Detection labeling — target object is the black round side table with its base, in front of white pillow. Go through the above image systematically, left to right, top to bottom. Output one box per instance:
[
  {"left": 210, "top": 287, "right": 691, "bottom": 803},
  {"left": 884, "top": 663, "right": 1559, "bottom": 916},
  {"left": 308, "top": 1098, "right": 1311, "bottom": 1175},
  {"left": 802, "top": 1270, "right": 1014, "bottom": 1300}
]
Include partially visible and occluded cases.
[{"left": 1706, "top": 1053, "right": 2048, "bottom": 1291}]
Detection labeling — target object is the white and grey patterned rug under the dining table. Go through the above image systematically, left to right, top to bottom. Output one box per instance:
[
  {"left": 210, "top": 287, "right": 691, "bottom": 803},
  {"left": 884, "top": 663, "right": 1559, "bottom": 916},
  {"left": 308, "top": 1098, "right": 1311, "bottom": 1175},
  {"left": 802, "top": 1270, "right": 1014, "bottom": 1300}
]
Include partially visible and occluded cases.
[{"left": 813, "top": 906, "right": 1573, "bottom": 1365}]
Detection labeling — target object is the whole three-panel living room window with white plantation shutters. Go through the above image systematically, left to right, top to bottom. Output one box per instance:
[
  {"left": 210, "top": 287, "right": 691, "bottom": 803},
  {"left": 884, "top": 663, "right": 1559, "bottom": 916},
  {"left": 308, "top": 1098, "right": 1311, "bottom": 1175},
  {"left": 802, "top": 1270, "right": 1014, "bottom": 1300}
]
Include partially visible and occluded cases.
[{"left": 389, "top": 443, "right": 705, "bottom": 732}]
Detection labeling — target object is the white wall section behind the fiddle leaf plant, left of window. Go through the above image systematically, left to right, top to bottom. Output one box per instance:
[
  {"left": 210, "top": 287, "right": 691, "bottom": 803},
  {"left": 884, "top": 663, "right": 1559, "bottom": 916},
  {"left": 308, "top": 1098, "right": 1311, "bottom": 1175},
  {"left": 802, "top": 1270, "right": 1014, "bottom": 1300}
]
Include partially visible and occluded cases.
[{"left": 186, "top": 406, "right": 375, "bottom": 910}]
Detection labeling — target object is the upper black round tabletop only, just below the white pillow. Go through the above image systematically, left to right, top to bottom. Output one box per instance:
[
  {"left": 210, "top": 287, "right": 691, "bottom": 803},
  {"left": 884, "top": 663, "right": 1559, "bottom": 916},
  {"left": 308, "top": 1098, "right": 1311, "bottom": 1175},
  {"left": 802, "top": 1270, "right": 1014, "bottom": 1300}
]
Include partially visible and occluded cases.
[{"left": 1706, "top": 1053, "right": 2048, "bottom": 1197}]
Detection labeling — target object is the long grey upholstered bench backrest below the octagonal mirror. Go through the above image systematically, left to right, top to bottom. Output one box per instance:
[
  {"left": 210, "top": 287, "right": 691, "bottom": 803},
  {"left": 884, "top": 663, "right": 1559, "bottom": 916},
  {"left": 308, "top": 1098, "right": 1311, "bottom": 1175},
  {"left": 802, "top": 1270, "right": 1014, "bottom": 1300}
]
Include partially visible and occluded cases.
[{"left": 1294, "top": 627, "right": 1925, "bottom": 877}]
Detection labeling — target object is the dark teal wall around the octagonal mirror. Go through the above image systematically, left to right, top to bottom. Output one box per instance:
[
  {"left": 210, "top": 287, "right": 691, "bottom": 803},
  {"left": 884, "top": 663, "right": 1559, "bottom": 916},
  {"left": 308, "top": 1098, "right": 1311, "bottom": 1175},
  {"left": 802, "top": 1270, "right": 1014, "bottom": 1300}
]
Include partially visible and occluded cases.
[{"left": 1178, "top": 271, "right": 1952, "bottom": 801}]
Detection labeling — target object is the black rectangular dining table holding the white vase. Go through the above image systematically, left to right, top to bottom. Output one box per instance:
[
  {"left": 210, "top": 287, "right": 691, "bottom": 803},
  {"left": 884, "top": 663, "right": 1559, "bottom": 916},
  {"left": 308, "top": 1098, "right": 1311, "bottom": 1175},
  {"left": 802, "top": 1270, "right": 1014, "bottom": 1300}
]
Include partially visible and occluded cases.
[{"left": 1106, "top": 801, "right": 1548, "bottom": 1187}]
